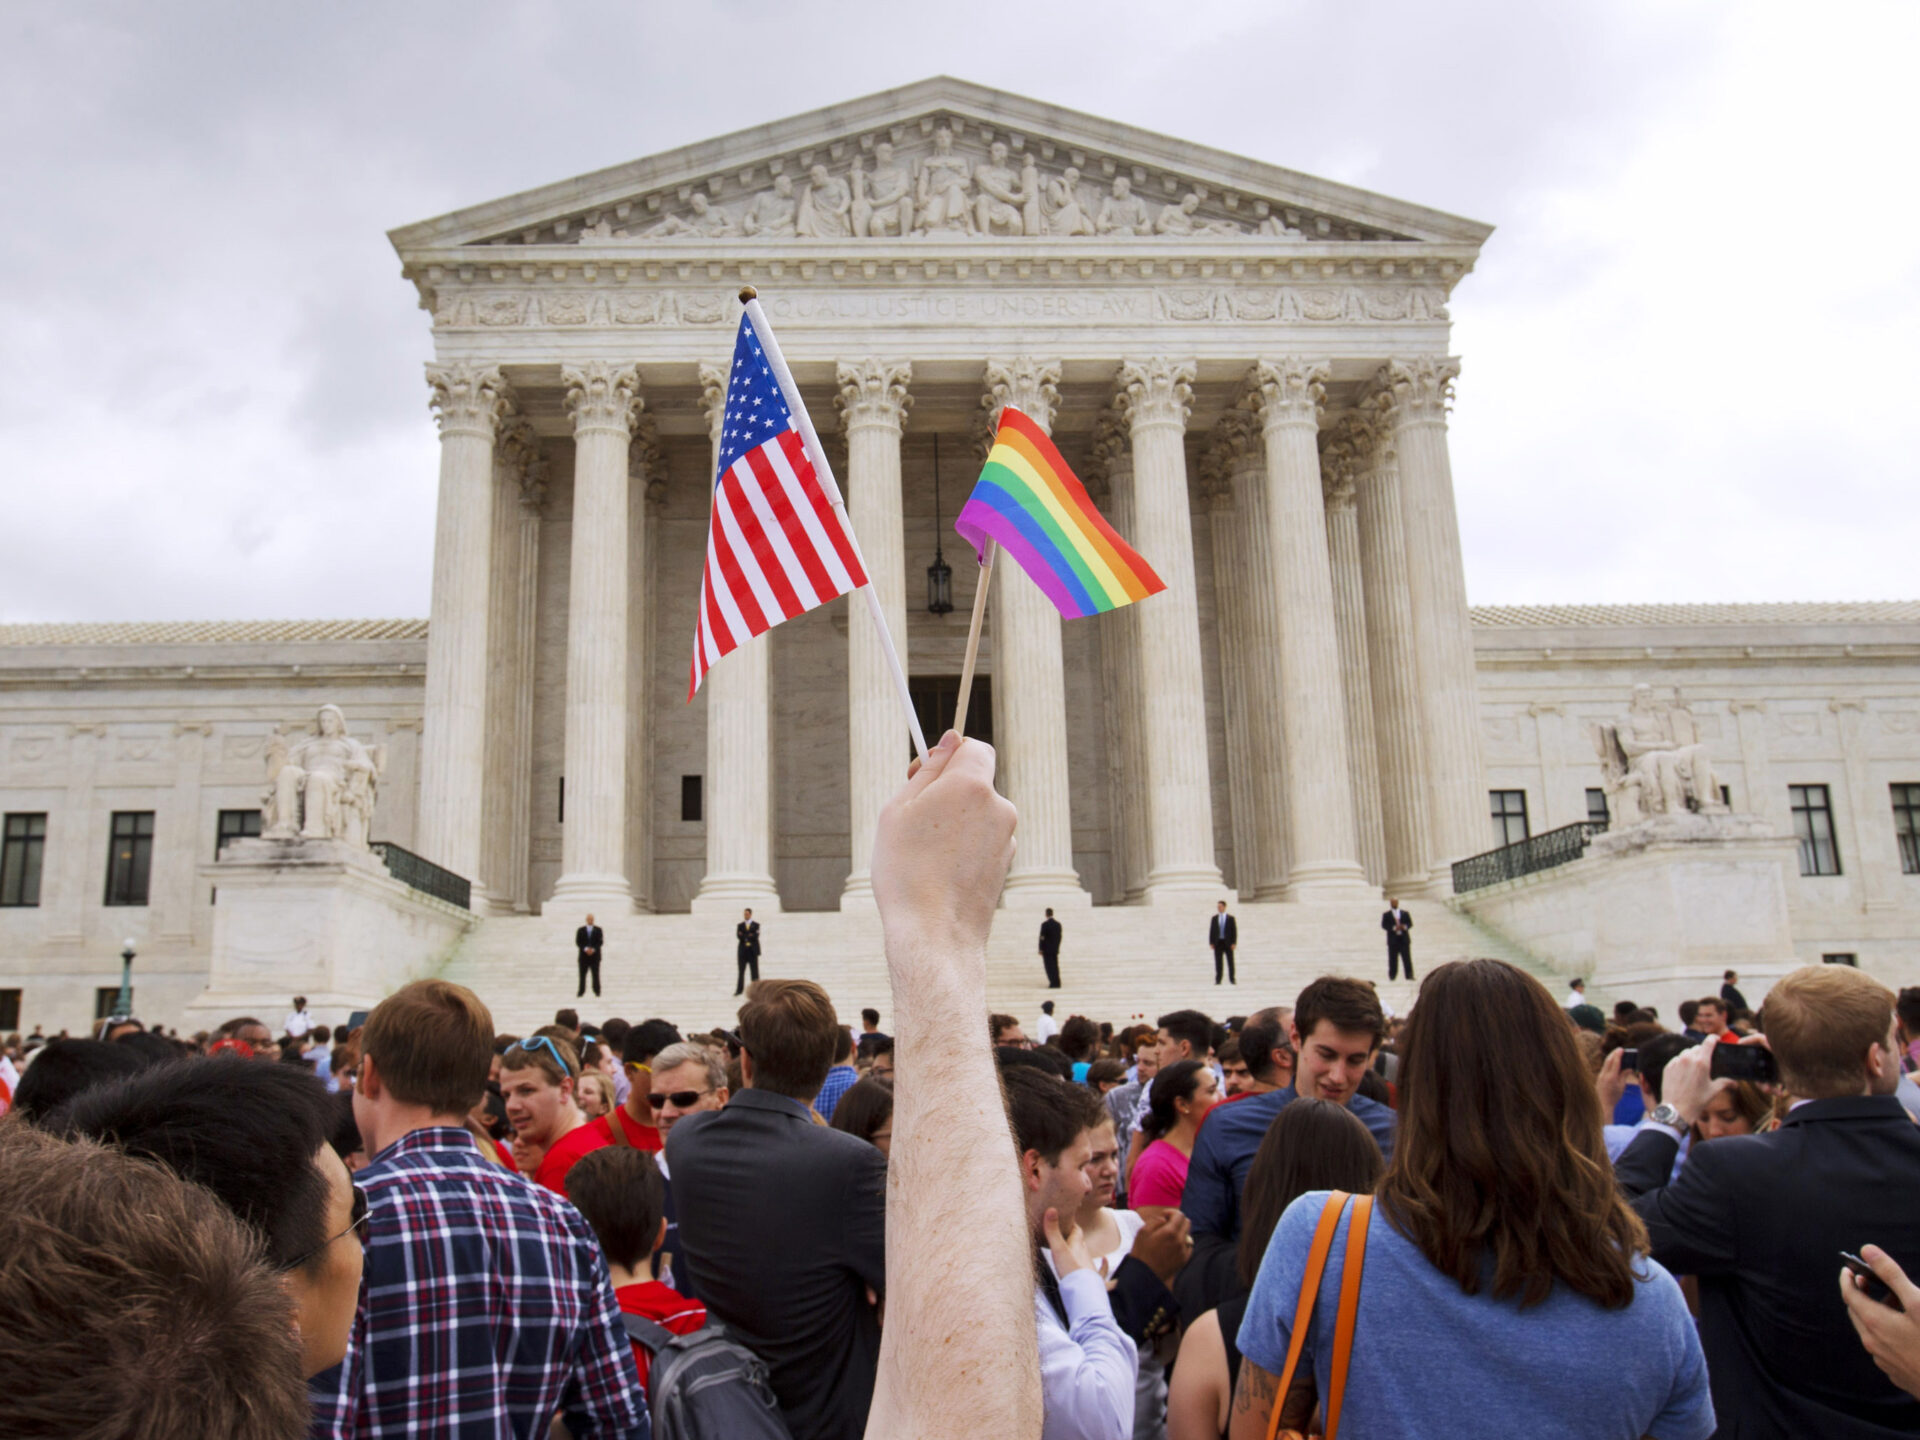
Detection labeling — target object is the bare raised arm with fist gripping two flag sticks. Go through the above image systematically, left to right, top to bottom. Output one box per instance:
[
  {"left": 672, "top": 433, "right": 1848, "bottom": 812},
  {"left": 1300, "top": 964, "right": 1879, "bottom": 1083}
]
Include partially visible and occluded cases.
[{"left": 866, "top": 732, "right": 1041, "bottom": 1440}]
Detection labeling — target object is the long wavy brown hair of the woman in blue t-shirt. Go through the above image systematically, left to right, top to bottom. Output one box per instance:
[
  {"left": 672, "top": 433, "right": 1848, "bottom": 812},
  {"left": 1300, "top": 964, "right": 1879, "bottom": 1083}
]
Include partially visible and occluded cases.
[{"left": 1379, "top": 960, "right": 1647, "bottom": 1309}]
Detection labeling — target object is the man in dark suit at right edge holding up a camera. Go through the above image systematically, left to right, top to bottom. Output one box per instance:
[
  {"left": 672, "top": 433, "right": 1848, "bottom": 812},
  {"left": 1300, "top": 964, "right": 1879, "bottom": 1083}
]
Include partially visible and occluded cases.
[{"left": 1615, "top": 966, "right": 1920, "bottom": 1440}]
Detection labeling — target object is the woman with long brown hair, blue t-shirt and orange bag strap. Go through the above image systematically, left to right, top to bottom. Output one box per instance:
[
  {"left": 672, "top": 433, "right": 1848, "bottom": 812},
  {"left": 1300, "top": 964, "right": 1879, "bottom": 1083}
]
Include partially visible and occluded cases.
[{"left": 1229, "top": 960, "right": 1715, "bottom": 1440}]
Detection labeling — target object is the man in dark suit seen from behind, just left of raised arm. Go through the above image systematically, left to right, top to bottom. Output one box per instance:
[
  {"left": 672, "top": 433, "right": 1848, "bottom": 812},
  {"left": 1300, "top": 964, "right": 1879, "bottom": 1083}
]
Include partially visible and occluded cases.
[{"left": 666, "top": 979, "right": 887, "bottom": 1440}]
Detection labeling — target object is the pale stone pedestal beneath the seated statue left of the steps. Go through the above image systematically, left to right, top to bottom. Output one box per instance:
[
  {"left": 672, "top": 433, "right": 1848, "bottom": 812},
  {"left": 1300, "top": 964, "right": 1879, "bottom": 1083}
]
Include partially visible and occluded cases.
[{"left": 182, "top": 839, "right": 474, "bottom": 1029}]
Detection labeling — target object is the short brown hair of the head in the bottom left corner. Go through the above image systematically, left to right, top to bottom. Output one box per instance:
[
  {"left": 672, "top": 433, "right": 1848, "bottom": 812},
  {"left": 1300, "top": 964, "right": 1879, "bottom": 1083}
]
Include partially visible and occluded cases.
[{"left": 0, "top": 1128, "right": 311, "bottom": 1440}]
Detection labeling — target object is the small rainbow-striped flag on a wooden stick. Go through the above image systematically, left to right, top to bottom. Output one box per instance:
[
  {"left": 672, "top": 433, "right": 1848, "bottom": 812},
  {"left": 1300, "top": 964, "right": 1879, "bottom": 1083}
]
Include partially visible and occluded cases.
[{"left": 954, "top": 407, "right": 1167, "bottom": 620}]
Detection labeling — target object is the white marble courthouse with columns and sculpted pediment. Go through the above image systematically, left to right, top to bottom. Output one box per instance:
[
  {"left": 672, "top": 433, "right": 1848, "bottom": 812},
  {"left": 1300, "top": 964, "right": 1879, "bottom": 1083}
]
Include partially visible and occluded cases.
[{"left": 0, "top": 79, "right": 1920, "bottom": 1029}]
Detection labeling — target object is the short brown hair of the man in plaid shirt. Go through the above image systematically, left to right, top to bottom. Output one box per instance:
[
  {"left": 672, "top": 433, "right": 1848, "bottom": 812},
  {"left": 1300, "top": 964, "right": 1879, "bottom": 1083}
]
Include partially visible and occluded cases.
[{"left": 359, "top": 979, "right": 493, "bottom": 1116}]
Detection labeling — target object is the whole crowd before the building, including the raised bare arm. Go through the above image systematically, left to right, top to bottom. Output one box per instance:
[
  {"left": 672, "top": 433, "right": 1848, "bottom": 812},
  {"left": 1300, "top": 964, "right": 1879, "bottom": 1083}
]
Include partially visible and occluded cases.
[{"left": 0, "top": 735, "right": 1920, "bottom": 1440}]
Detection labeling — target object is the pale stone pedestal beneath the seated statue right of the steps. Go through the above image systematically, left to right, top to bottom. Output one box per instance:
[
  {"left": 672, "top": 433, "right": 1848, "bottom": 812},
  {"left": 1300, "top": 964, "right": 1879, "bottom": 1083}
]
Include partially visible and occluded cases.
[{"left": 1453, "top": 814, "right": 1801, "bottom": 1027}]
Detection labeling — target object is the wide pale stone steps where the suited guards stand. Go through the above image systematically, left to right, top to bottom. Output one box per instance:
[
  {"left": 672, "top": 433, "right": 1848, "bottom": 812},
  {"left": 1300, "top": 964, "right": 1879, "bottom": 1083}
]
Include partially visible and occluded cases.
[{"left": 442, "top": 900, "right": 1559, "bottom": 1033}]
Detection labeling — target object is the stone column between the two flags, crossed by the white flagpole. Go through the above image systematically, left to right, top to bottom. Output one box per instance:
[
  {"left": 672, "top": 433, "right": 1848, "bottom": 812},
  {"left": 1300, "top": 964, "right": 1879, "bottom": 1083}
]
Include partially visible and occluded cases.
[{"left": 837, "top": 359, "right": 914, "bottom": 910}]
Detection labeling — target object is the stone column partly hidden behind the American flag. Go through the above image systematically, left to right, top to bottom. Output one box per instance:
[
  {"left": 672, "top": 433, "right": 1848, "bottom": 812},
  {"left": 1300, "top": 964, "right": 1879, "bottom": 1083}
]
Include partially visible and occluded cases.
[{"left": 693, "top": 361, "right": 780, "bottom": 914}]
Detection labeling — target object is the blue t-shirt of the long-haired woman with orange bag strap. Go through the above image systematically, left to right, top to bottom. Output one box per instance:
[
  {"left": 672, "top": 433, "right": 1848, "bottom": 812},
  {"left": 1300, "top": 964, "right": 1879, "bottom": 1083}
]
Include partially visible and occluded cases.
[{"left": 1240, "top": 1190, "right": 1715, "bottom": 1440}]
